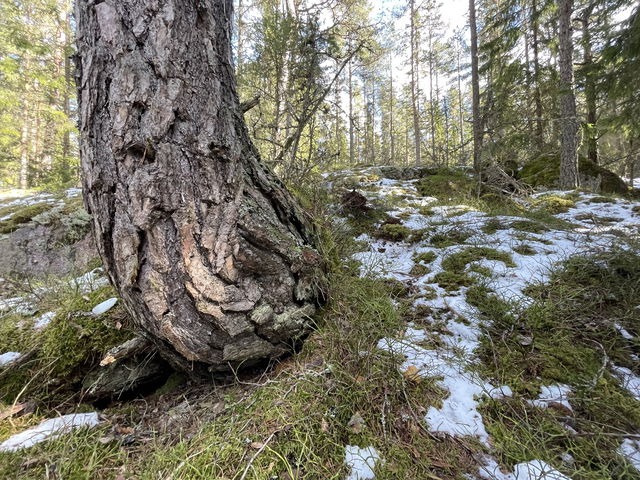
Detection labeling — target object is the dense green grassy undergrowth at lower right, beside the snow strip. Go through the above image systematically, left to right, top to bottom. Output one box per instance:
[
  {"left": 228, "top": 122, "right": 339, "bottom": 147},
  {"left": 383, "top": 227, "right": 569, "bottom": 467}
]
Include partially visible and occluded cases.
[{"left": 466, "top": 249, "right": 640, "bottom": 480}]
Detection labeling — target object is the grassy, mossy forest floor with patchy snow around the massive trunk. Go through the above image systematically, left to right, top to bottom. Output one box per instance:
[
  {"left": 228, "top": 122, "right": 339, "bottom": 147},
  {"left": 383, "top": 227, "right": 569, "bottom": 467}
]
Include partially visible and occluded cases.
[{"left": 0, "top": 167, "right": 640, "bottom": 480}]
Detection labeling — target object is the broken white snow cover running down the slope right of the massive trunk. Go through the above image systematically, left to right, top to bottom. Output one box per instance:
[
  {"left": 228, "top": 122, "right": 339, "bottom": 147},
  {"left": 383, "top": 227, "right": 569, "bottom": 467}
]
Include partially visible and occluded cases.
[{"left": 336, "top": 170, "right": 640, "bottom": 480}]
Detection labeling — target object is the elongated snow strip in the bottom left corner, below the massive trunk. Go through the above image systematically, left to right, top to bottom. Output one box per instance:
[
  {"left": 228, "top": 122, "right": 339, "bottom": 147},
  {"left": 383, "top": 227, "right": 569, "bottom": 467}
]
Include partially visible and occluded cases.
[{"left": 0, "top": 412, "right": 100, "bottom": 452}]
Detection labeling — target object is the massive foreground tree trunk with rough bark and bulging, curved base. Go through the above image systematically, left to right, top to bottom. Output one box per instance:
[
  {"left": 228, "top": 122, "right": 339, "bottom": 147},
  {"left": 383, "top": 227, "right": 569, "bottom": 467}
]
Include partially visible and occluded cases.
[{"left": 76, "top": 0, "right": 320, "bottom": 374}]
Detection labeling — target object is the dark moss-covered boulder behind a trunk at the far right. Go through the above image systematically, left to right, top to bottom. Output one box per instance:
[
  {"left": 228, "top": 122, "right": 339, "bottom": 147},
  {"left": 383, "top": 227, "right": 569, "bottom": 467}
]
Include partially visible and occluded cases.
[{"left": 518, "top": 154, "right": 629, "bottom": 195}]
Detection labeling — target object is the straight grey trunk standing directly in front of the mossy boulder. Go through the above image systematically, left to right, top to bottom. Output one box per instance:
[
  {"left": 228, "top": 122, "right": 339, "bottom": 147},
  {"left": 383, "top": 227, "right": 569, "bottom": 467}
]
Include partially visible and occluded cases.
[{"left": 558, "top": 0, "right": 580, "bottom": 189}]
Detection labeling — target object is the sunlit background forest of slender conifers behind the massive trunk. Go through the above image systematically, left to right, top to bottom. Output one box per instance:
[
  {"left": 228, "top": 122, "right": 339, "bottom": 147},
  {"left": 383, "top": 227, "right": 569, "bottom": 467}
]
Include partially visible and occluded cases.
[{"left": 0, "top": 0, "right": 640, "bottom": 189}]
